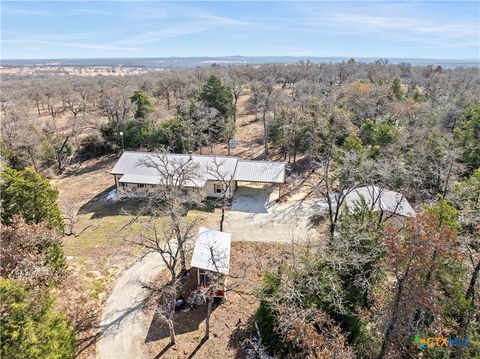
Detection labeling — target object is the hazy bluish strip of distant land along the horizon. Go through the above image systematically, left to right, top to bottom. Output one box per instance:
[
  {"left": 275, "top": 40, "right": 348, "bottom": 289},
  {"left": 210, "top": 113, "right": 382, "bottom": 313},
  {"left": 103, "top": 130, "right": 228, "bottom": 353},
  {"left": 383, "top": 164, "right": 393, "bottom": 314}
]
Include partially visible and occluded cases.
[{"left": 0, "top": 56, "right": 480, "bottom": 69}]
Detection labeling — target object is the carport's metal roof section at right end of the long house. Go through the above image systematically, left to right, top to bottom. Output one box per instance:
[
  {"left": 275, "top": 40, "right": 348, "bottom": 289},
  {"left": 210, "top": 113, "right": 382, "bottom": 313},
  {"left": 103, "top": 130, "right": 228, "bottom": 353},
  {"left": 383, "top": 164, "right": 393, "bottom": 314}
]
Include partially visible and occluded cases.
[{"left": 233, "top": 160, "right": 285, "bottom": 183}]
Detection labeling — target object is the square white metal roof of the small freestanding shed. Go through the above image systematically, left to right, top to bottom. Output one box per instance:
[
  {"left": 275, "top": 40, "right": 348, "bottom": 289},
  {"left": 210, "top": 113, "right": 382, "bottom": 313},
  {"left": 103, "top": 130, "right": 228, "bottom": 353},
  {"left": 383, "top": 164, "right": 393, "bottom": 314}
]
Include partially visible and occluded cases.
[{"left": 190, "top": 227, "right": 232, "bottom": 274}]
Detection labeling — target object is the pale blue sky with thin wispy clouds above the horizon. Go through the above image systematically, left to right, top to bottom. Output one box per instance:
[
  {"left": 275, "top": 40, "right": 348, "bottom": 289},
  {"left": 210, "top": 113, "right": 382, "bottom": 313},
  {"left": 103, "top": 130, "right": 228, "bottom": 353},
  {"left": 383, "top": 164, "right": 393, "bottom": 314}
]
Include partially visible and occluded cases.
[{"left": 1, "top": 1, "right": 480, "bottom": 59}]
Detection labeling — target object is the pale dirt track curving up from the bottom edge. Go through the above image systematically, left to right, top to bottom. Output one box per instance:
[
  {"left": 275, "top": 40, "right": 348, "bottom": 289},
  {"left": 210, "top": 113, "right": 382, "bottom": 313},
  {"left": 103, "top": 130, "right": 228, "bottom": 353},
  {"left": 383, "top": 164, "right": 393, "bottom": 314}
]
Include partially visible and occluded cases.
[{"left": 97, "top": 253, "right": 164, "bottom": 359}]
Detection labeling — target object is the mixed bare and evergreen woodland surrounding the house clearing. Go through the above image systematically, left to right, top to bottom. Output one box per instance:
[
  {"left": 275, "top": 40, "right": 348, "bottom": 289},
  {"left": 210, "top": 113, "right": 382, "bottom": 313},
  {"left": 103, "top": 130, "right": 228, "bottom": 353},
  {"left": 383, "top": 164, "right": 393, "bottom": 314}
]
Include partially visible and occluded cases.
[{"left": 0, "top": 59, "right": 480, "bottom": 358}]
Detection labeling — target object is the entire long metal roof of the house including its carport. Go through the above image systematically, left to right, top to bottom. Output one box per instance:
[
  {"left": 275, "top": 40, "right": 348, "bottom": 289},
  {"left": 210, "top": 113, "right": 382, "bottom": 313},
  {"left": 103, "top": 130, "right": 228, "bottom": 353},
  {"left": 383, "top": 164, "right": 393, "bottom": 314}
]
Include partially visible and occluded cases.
[{"left": 111, "top": 151, "right": 285, "bottom": 187}]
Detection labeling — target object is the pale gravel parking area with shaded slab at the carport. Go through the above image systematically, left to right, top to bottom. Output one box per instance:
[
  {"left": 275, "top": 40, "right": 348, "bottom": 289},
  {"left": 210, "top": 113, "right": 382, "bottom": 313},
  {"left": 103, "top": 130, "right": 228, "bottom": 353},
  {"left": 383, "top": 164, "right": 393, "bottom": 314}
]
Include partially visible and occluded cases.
[{"left": 225, "top": 183, "right": 322, "bottom": 242}]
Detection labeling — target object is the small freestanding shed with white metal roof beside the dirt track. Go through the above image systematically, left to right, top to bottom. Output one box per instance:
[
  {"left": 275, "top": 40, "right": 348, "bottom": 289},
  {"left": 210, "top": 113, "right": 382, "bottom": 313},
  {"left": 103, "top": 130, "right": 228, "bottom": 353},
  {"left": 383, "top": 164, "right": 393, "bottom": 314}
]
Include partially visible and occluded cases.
[{"left": 190, "top": 227, "right": 232, "bottom": 297}]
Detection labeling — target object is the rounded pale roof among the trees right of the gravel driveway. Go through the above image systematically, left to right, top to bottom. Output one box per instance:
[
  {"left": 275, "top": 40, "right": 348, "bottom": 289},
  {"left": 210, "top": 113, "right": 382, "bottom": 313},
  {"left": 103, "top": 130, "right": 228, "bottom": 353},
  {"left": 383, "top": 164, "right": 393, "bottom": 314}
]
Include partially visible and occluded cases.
[{"left": 340, "top": 185, "right": 415, "bottom": 217}]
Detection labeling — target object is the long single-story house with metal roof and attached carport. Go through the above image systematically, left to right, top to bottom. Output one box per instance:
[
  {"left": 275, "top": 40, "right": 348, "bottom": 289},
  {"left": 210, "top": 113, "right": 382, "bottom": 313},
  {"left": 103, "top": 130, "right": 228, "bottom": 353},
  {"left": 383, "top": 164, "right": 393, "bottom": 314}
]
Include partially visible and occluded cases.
[{"left": 111, "top": 151, "right": 285, "bottom": 198}]
